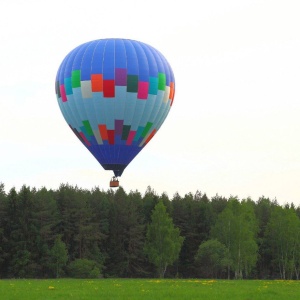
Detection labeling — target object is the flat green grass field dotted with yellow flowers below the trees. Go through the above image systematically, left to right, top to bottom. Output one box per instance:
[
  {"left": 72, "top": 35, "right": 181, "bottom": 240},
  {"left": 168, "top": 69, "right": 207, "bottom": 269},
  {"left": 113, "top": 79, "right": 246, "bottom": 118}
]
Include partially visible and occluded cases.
[{"left": 0, "top": 279, "right": 300, "bottom": 300}]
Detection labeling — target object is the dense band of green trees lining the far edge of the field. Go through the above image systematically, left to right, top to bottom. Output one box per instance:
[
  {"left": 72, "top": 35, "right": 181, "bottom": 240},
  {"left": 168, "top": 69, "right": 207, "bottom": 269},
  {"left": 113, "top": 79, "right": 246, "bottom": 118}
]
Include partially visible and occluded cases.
[{"left": 0, "top": 183, "right": 300, "bottom": 280}]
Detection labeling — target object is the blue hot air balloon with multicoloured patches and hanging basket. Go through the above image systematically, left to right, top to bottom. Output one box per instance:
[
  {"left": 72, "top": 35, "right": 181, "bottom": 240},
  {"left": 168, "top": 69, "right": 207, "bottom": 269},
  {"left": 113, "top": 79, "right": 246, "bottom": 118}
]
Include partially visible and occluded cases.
[{"left": 55, "top": 38, "right": 175, "bottom": 187}]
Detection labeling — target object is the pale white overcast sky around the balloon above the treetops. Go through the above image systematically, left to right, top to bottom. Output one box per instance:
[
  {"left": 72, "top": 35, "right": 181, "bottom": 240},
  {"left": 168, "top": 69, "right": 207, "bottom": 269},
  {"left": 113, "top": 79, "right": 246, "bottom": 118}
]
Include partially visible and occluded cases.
[{"left": 0, "top": 0, "right": 300, "bottom": 205}]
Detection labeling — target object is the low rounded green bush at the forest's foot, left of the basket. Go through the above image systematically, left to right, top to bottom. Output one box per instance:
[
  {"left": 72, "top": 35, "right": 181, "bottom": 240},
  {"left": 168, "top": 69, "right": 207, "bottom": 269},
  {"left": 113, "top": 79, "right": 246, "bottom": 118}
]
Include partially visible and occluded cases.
[{"left": 67, "top": 258, "right": 100, "bottom": 278}]
